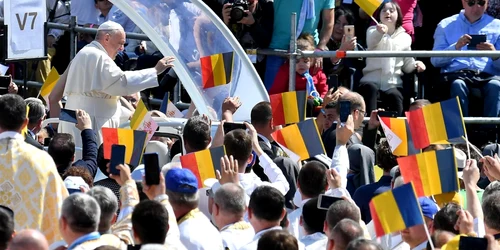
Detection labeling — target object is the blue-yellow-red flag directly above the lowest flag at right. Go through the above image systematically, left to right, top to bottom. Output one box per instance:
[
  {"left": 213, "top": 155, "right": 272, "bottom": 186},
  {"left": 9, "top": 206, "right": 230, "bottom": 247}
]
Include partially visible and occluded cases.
[{"left": 398, "top": 148, "right": 459, "bottom": 197}]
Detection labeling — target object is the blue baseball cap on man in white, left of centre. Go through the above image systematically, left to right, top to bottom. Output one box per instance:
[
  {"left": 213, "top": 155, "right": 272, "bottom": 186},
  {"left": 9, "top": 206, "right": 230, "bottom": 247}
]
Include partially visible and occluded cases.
[{"left": 165, "top": 168, "right": 198, "bottom": 194}]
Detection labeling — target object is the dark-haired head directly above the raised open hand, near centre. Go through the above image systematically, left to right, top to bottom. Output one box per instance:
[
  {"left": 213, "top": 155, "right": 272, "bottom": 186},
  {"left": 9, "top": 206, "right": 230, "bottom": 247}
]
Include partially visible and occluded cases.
[{"left": 224, "top": 129, "right": 252, "bottom": 167}]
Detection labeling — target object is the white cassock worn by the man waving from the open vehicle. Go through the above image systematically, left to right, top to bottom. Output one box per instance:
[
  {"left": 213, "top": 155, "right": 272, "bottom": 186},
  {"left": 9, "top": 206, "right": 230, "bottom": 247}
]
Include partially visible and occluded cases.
[{"left": 59, "top": 41, "right": 158, "bottom": 147}]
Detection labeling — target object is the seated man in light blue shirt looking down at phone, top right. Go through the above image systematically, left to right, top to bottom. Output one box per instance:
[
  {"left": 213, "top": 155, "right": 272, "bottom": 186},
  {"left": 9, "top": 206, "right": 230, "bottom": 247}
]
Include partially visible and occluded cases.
[{"left": 431, "top": 0, "right": 500, "bottom": 117}]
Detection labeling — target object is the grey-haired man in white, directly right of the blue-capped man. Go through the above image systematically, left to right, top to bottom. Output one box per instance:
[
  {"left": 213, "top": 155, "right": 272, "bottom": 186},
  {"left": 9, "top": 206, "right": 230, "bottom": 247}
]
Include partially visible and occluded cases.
[{"left": 212, "top": 183, "right": 255, "bottom": 250}]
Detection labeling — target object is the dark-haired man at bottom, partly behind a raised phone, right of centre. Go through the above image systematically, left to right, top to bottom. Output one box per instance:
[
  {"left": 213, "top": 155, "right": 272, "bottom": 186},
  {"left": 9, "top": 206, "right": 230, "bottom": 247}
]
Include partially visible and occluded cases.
[{"left": 299, "top": 198, "right": 328, "bottom": 250}]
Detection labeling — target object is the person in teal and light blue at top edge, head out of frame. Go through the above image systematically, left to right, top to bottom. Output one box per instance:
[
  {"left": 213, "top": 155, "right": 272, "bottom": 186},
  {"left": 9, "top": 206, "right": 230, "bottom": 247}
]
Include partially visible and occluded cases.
[{"left": 264, "top": 0, "right": 335, "bottom": 90}]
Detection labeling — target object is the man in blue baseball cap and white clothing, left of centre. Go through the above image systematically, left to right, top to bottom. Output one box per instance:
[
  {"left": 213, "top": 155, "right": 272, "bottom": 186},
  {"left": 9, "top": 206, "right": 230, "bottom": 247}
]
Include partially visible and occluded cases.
[{"left": 165, "top": 168, "right": 223, "bottom": 250}]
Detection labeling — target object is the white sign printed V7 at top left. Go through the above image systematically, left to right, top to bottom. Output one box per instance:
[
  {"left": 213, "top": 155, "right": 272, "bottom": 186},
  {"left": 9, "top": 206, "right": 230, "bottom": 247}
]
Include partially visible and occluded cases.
[{"left": 3, "top": 0, "right": 47, "bottom": 59}]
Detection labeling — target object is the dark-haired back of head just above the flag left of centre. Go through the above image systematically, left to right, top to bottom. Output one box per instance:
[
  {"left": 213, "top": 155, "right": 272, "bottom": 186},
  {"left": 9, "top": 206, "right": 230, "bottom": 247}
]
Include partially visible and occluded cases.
[{"left": 182, "top": 116, "right": 210, "bottom": 151}]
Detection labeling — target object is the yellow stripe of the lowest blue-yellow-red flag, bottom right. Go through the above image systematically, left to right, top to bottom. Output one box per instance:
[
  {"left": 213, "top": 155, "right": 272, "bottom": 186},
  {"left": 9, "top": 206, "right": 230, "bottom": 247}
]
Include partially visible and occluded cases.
[{"left": 372, "top": 192, "right": 406, "bottom": 232}]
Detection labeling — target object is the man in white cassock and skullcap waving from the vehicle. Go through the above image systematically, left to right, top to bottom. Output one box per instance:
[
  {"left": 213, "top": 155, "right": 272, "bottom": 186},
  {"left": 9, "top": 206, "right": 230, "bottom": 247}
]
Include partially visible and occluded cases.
[{"left": 49, "top": 21, "right": 174, "bottom": 146}]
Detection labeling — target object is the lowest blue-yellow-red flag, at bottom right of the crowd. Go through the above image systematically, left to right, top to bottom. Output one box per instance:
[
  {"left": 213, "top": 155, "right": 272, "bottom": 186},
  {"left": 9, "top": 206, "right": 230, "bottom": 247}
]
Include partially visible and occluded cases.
[{"left": 370, "top": 183, "right": 424, "bottom": 237}]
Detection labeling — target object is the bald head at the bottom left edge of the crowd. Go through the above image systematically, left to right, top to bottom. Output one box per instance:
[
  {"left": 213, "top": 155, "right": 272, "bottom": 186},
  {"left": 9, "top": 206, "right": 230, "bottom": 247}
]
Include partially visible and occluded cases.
[{"left": 9, "top": 229, "right": 49, "bottom": 250}]
